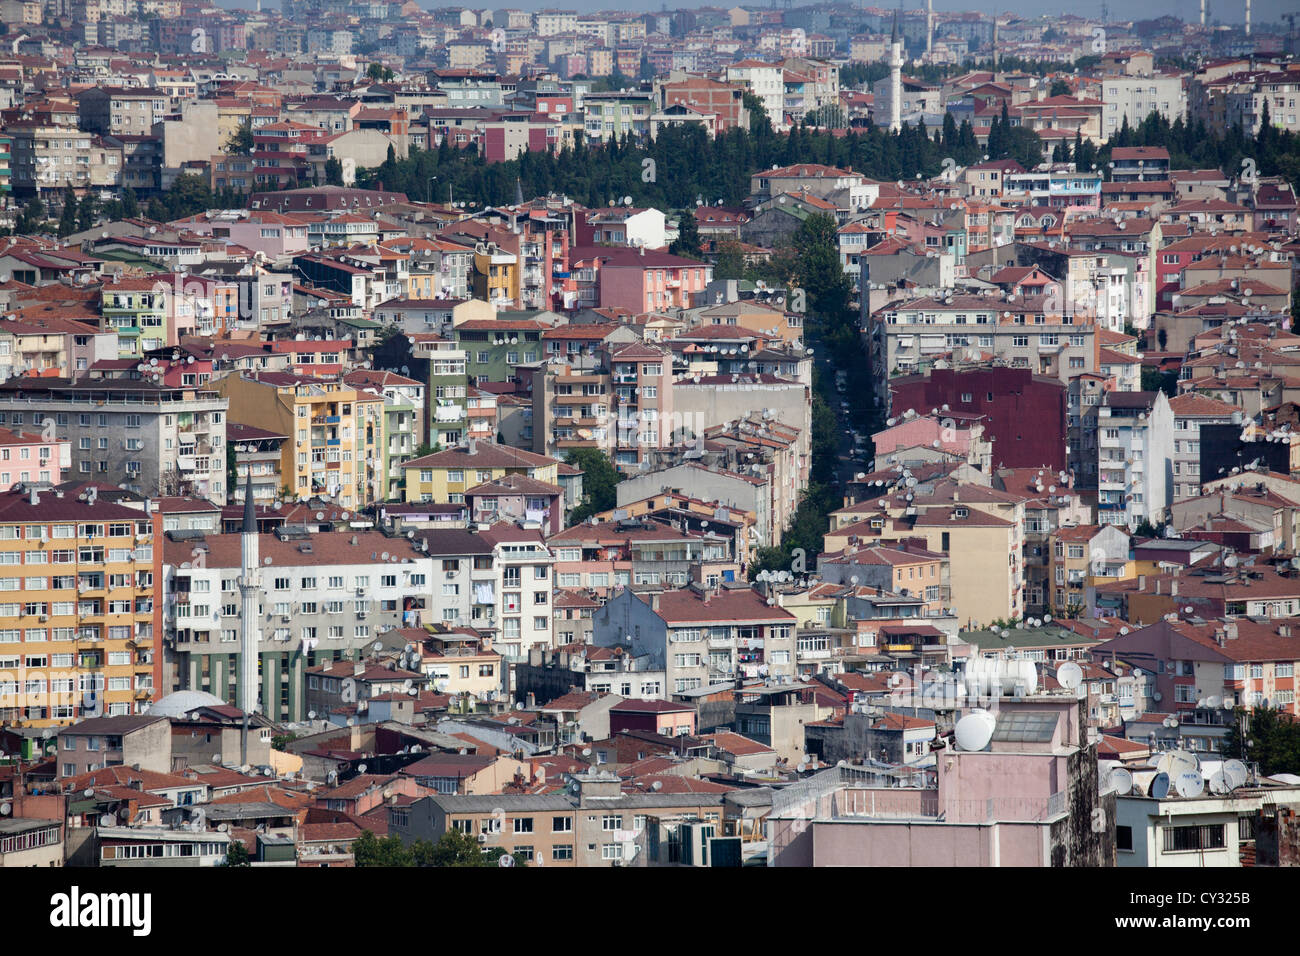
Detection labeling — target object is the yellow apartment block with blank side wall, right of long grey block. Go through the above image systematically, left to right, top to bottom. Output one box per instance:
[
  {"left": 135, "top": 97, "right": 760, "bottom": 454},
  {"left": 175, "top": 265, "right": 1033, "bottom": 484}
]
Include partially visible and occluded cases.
[{"left": 216, "top": 372, "right": 386, "bottom": 507}]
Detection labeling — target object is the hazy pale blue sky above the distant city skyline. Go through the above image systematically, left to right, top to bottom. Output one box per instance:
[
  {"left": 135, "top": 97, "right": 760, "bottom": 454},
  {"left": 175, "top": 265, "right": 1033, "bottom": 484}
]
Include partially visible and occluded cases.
[{"left": 217, "top": 0, "right": 1300, "bottom": 25}]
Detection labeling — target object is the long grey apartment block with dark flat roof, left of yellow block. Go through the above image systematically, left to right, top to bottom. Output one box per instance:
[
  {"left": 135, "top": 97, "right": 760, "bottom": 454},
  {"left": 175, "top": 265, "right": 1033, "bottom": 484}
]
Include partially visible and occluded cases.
[{"left": 0, "top": 378, "right": 229, "bottom": 503}]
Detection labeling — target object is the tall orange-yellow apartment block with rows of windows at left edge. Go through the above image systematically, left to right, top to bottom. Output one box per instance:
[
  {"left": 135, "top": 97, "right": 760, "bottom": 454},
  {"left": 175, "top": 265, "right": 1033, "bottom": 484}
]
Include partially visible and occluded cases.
[{"left": 0, "top": 492, "right": 155, "bottom": 727}]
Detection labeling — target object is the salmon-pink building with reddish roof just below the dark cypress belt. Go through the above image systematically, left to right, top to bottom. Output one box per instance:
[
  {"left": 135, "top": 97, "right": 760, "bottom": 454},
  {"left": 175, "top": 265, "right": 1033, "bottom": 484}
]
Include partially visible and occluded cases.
[{"left": 569, "top": 246, "right": 714, "bottom": 315}]
